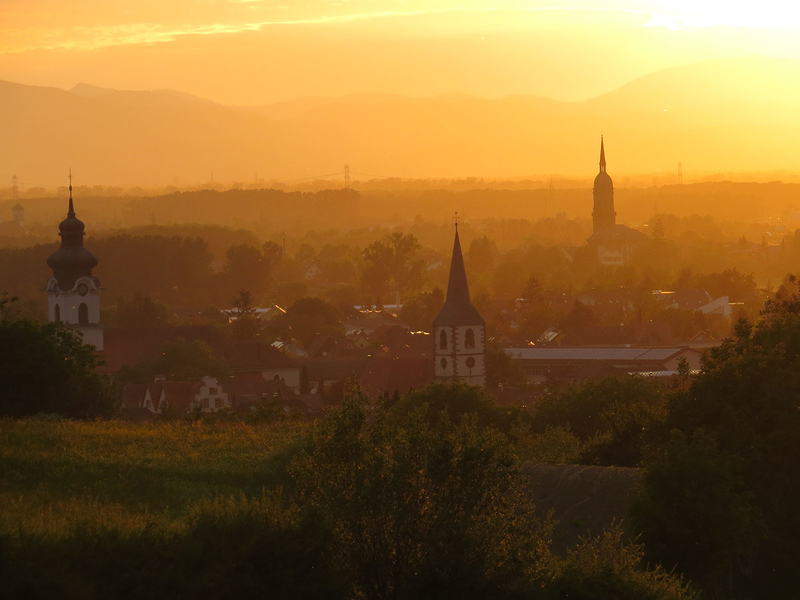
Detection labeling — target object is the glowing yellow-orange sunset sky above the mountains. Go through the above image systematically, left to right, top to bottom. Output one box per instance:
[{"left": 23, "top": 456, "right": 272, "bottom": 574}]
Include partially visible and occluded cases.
[{"left": 0, "top": 0, "right": 800, "bottom": 105}]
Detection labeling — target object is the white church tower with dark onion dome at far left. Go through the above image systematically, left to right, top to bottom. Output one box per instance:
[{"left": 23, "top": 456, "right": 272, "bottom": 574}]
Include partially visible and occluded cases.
[{"left": 45, "top": 170, "right": 103, "bottom": 350}]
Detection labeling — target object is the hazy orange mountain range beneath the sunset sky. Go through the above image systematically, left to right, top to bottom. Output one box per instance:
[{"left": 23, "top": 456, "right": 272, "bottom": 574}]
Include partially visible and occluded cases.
[{"left": 0, "top": 57, "right": 800, "bottom": 186}]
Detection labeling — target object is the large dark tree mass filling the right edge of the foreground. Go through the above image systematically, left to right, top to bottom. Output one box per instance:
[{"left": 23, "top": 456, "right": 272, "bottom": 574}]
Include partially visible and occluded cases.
[{"left": 641, "top": 281, "right": 800, "bottom": 598}]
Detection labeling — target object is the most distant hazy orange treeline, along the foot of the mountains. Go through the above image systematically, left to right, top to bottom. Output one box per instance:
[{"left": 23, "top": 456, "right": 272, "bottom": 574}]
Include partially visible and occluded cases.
[{"left": 7, "top": 180, "right": 800, "bottom": 235}]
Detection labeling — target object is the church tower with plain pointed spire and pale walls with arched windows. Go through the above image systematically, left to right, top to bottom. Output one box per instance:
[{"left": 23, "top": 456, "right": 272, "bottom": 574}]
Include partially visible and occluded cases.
[{"left": 433, "top": 223, "right": 486, "bottom": 386}]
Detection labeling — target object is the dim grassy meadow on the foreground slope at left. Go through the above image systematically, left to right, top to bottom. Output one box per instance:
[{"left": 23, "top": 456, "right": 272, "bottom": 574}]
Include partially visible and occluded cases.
[{"left": 0, "top": 420, "right": 309, "bottom": 536}]
